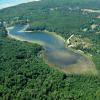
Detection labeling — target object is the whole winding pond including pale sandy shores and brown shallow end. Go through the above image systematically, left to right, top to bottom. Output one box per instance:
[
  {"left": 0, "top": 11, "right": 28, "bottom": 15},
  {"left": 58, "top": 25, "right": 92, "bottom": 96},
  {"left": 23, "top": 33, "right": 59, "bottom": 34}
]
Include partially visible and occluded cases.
[{"left": 7, "top": 25, "right": 97, "bottom": 74}]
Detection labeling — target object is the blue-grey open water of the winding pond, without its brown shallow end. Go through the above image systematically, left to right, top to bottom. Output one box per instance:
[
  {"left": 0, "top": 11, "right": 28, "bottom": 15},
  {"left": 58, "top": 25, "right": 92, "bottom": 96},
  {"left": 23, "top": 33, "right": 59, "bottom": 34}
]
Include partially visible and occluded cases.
[{"left": 8, "top": 25, "right": 96, "bottom": 73}]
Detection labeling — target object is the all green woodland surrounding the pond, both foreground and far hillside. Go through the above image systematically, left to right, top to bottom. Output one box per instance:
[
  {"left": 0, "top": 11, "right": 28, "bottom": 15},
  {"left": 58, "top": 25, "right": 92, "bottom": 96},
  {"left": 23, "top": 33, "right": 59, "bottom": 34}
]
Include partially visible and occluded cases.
[{"left": 0, "top": 0, "right": 100, "bottom": 100}]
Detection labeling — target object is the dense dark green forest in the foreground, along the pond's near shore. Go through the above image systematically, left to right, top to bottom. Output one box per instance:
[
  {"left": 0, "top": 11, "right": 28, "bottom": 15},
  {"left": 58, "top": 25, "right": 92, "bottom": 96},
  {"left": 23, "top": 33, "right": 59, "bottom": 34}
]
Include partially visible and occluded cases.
[{"left": 0, "top": 28, "right": 100, "bottom": 100}]
